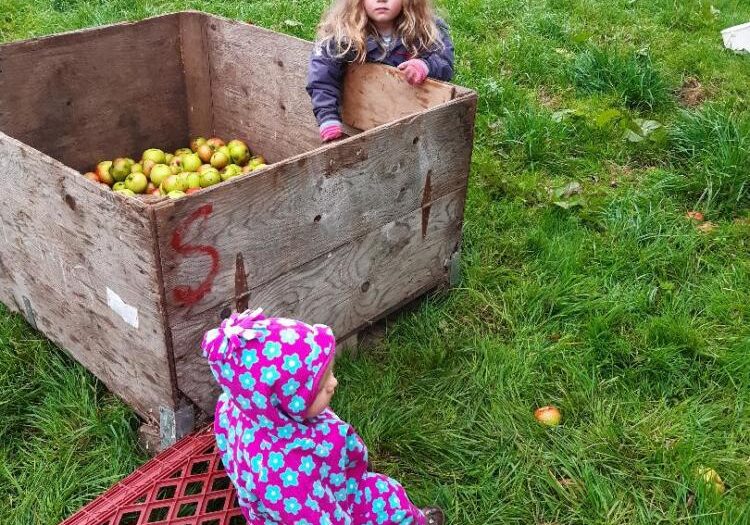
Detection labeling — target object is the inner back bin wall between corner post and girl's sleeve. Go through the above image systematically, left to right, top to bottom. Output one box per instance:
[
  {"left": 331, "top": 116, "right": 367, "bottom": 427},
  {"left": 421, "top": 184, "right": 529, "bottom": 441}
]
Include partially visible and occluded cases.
[{"left": 206, "top": 17, "right": 320, "bottom": 162}]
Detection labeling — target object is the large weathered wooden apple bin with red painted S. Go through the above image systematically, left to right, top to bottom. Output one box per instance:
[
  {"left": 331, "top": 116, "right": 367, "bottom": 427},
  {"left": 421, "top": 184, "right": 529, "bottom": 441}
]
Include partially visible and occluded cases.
[{"left": 0, "top": 12, "right": 476, "bottom": 434}]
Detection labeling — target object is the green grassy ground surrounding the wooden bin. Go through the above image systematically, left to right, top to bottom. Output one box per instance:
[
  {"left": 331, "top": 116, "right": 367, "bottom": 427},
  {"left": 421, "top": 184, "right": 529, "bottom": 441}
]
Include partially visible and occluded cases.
[{"left": 0, "top": 0, "right": 750, "bottom": 525}]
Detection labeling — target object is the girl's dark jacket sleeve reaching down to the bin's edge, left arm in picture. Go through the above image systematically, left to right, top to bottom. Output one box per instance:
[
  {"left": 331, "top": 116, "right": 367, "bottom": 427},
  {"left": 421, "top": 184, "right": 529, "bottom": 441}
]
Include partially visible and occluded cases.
[{"left": 307, "top": 42, "right": 346, "bottom": 126}]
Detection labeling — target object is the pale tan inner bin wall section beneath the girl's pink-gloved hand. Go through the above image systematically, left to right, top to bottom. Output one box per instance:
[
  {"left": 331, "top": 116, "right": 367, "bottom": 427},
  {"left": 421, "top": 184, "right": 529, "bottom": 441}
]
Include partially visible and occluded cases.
[{"left": 341, "top": 63, "right": 456, "bottom": 130}]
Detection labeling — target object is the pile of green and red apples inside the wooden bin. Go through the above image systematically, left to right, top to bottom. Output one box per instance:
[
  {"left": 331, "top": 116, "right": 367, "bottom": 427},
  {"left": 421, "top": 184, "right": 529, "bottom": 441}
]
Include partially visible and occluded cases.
[{"left": 84, "top": 137, "right": 266, "bottom": 199}]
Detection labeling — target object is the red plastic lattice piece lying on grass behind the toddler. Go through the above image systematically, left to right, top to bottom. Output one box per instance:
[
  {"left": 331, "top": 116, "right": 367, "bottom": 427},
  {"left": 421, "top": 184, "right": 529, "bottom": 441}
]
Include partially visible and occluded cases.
[{"left": 61, "top": 428, "right": 246, "bottom": 525}]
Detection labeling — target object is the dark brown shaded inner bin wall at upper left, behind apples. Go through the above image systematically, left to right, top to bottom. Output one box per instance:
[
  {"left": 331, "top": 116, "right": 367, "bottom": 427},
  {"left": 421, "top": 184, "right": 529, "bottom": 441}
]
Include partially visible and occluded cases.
[{"left": 0, "top": 15, "right": 188, "bottom": 171}]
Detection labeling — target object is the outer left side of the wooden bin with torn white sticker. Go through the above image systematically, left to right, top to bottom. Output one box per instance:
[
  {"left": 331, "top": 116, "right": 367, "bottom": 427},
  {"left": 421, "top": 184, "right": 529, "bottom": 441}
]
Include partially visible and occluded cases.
[{"left": 0, "top": 133, "right": 174, "bottom": 417}]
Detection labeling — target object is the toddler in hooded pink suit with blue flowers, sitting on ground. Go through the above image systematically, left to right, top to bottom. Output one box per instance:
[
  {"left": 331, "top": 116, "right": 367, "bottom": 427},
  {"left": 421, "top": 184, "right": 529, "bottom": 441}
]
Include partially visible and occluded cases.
[{"left": 202, "top": 310, "right": 442, "bottom": 525}]
